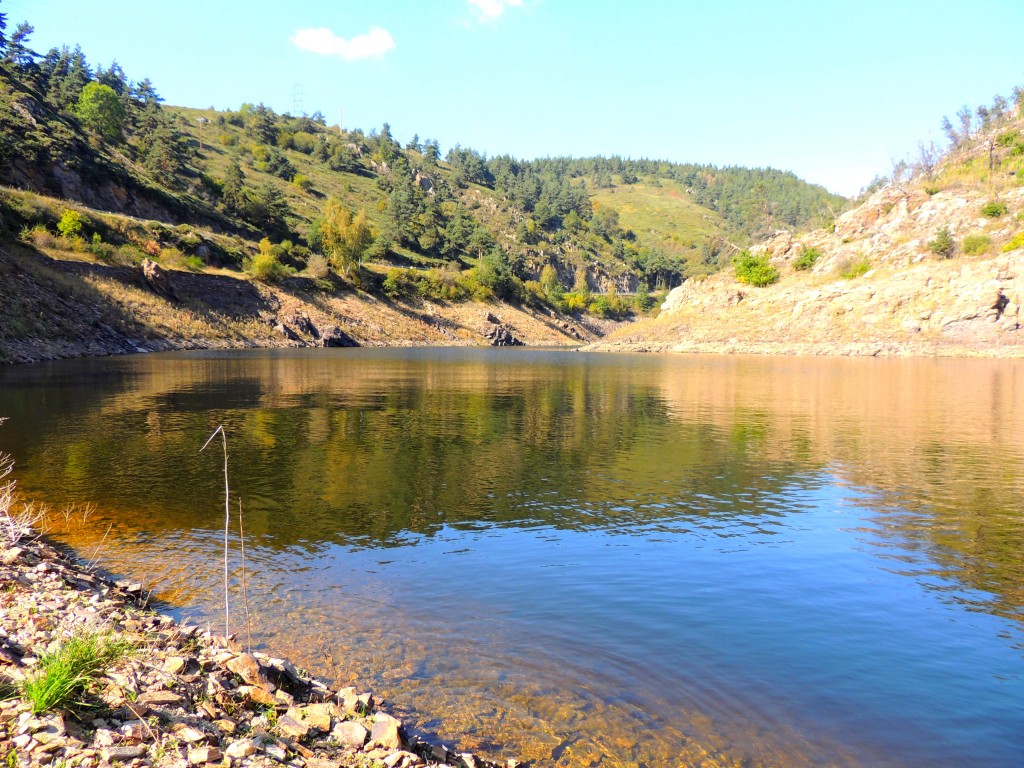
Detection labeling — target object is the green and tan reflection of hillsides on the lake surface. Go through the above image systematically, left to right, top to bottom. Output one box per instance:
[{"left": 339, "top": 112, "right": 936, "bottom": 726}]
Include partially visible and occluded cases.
[{"left": 0, "top": 352, "right": 1024, "bottom": 617}]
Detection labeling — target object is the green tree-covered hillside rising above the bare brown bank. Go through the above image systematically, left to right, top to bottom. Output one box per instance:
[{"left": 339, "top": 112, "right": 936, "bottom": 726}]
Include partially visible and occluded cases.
[{"left": 0, "top": 11, "right": 845, "bottom": 342}]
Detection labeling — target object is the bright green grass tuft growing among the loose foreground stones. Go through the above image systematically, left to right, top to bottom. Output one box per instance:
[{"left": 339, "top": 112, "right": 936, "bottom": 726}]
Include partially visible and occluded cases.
[{"left": 22, "top": 634, "right": 131, "bottom": 714}]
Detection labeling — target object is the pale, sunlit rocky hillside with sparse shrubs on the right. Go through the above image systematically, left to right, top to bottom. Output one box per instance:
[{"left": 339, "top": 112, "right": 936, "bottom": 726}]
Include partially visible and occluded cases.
[{"left": 596, "top": 99, "right": 1024, "bottom": 356}]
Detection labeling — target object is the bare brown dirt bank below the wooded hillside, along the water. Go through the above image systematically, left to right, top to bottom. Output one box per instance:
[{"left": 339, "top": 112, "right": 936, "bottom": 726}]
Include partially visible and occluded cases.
[{"left": 0, "top": 246, "right": 600, "bottom": 365}]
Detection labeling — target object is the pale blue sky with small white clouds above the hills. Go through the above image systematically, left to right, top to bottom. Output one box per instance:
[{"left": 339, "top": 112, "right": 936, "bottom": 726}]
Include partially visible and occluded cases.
[{"left": 8, "top": 0, "right": 1024, "bottom": 195}]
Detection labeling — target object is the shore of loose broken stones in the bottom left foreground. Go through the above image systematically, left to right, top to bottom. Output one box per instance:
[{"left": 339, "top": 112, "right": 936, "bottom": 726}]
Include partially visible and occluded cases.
[{"left": 0, "top": 537, "right": 519, "bottom": 768}]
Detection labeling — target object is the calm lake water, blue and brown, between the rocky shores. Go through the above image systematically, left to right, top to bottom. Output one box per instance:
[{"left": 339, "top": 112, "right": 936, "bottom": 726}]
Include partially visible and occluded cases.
[{"left": 0, "top": 350, "right": 1024, "bottom": 766}]
